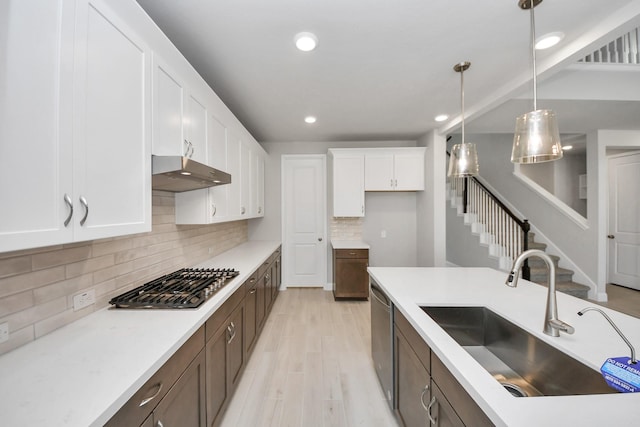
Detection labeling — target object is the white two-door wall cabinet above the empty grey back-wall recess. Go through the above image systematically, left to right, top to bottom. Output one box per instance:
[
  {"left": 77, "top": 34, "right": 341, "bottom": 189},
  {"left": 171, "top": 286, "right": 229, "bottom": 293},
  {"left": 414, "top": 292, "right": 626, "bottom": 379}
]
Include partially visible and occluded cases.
[{"left": 364, "top": 147, "right": 425, "bottom": 191}]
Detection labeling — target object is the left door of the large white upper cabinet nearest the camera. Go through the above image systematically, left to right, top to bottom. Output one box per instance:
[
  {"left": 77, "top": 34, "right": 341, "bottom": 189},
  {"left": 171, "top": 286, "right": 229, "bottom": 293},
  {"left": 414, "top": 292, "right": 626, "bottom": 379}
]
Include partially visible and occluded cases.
[{"left": 0, "top": 0, "right": 74, "bottom": 252}]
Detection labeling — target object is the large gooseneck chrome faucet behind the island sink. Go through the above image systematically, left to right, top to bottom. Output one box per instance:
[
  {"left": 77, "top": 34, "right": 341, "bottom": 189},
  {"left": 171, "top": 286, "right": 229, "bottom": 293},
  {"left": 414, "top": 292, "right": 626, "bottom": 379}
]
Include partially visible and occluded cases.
[{"left": 505, "top": 249, "right": 575, "bottom": 337}]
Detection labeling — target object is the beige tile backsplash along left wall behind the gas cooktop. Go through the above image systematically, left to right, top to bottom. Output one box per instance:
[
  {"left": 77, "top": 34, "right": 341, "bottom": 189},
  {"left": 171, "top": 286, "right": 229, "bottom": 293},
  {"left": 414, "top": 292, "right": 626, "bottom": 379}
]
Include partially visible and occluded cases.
[{"left": 0, "top": 191, "right": 248, "bottom": 354}]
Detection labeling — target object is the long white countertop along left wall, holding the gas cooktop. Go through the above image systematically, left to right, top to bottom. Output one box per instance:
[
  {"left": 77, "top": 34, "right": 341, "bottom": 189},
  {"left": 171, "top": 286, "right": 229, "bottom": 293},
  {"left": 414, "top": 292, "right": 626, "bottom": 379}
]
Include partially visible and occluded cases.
[{"left": 0, "top": 241, "right": 280, "bottom": 427}]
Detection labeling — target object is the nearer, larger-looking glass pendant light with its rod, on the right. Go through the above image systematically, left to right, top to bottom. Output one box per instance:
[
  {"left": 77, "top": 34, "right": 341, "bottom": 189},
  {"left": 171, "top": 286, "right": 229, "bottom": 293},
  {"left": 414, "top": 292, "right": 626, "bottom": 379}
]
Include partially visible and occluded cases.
[{"left": 511, "top": 0, "right": 562, "bottom": 163}]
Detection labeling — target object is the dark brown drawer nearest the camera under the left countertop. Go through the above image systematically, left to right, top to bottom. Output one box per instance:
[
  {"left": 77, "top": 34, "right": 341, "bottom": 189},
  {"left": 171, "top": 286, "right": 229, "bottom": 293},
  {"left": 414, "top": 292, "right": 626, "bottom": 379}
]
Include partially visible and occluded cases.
[{"left": 106, "top": 327, "right": 204, "bottom": 427}]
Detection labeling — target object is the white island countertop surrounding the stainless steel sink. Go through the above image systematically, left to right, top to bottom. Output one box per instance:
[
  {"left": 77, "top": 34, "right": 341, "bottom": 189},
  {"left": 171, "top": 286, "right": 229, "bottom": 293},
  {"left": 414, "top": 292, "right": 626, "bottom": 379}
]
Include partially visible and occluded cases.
[{"left": 369, "top": 267, "right": 640, "bottom": 427}]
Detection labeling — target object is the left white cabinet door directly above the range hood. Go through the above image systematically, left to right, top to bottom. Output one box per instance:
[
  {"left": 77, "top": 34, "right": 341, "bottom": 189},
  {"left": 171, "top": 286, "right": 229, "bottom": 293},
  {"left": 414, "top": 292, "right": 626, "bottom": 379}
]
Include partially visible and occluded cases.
[{"left": 152, "top": 55, "right": 186, "bottom": 156}]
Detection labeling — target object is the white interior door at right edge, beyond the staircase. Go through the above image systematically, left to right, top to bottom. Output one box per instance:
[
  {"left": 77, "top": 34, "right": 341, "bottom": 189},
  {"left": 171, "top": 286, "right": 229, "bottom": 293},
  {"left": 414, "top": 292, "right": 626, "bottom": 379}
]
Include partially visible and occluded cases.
[{"left": 608, "top": 154, "right": 640, "bottom": 290}]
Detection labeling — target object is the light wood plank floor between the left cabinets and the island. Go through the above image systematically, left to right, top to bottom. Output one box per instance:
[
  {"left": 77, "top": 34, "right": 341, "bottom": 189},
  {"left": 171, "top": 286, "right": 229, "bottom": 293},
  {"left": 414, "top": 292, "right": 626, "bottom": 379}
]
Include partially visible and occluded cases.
[{"left": 222, "top": 288, "right": 398, "bottom": 427}]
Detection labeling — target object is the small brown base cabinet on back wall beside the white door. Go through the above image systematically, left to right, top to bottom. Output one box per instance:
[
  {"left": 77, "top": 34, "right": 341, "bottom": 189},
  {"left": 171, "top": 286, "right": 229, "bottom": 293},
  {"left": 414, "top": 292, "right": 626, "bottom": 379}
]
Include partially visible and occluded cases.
[{"left": 333, "top": 247, "right": 369, "bottom": 299}]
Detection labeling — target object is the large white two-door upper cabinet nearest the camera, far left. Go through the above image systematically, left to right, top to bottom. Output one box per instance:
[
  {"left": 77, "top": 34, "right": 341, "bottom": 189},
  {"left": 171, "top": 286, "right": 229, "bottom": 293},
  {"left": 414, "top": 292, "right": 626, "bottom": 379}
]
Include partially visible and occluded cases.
[{"left": 0, "top": 0, "right": 151, "bottom": 251}]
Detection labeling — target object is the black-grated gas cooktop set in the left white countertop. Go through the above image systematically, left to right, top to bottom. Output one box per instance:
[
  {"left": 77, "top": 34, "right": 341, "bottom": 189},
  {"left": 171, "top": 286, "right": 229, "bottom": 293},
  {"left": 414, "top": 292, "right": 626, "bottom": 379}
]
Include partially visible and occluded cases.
[{"left": 109, "top": 268, "right": 240, "bottom": 308}]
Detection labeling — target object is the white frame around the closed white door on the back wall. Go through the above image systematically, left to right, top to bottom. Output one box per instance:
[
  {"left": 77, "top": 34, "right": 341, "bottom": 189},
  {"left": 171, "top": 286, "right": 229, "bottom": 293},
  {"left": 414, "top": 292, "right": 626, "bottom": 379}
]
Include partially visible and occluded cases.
[{"left": 280, "top": 154, "right": 331, "bottom": 290}]
